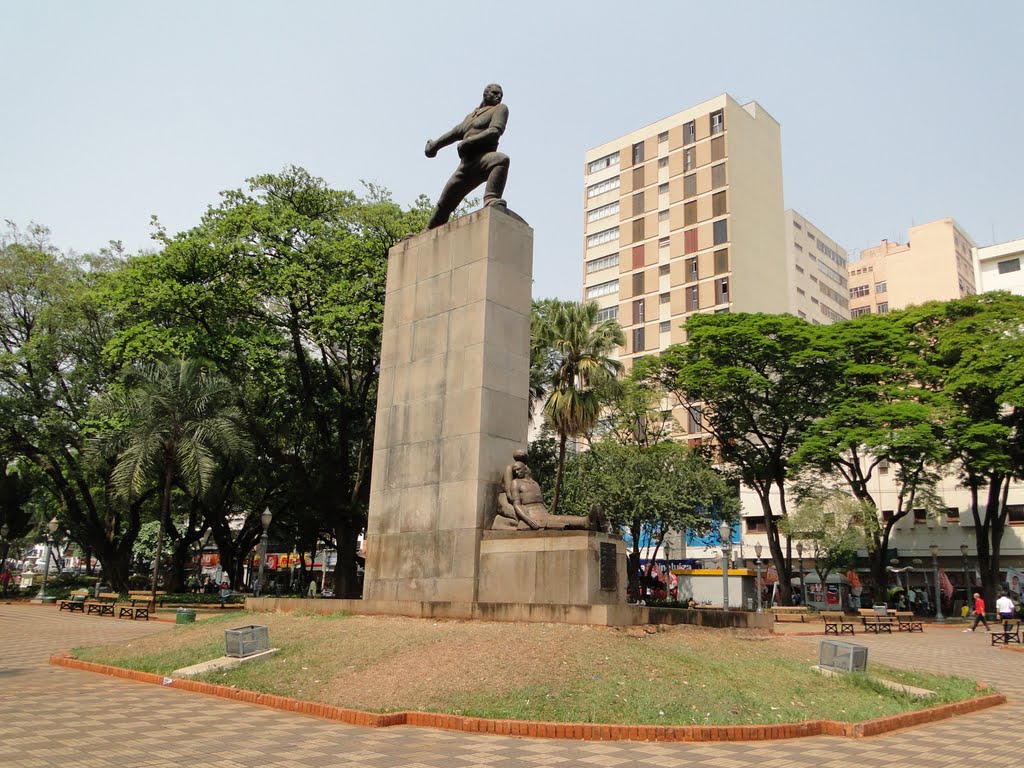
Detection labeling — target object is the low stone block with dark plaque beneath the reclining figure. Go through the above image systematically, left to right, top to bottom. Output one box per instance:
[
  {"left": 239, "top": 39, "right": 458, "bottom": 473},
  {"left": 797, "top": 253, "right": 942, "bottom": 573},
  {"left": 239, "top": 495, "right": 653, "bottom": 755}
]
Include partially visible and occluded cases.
[{"left": 479, "top": 530, "right": 626, "bottom": 605}]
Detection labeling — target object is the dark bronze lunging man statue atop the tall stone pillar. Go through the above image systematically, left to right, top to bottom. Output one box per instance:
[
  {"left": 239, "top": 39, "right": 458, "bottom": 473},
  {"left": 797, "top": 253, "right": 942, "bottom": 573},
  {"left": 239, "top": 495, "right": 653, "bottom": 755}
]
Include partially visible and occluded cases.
[{"left": 424, "top": 83, "right": 509, "bottom": 229}]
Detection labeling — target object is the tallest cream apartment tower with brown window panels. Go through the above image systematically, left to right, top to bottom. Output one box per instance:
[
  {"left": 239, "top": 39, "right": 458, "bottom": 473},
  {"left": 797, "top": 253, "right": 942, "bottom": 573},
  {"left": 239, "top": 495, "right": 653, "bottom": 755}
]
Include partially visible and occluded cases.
[{"left": 584, "top": 94, "right": 791, "bottom": 367}]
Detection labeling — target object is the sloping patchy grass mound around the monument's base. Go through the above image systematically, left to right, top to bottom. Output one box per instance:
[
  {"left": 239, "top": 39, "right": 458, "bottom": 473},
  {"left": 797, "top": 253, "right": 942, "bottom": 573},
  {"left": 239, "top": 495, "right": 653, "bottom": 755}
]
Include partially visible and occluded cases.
[{"left": 75, "top": 613, "right": 978, "bottom": 725}]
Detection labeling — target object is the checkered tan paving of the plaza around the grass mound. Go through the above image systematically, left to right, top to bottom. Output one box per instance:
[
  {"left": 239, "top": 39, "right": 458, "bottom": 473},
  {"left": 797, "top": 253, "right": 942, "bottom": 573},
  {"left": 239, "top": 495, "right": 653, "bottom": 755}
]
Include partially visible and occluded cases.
[{"left": 0, "top": 604, "right": 1024, "bottom": 768}]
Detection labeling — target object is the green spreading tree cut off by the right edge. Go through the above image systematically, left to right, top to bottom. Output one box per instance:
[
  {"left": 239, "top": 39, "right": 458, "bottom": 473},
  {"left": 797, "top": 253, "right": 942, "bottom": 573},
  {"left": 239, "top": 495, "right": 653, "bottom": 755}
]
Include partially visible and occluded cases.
[{"left": 901, "top": 292, "right": 1024, "bottom": 601}]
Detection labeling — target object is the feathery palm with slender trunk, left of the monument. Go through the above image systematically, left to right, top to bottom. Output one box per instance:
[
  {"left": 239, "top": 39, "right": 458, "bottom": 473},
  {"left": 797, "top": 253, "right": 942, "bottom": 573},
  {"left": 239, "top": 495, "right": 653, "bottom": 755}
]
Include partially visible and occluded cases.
[{"left": 96, "top": 359, "right": 249, "bottom": 600}]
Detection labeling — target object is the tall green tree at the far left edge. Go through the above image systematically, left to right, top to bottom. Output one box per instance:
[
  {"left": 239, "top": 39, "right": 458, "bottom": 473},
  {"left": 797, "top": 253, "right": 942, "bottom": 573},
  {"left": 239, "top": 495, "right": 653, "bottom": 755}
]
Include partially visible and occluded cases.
[{"left": 0, "top": 225, "right": 144, "bottom": 589}]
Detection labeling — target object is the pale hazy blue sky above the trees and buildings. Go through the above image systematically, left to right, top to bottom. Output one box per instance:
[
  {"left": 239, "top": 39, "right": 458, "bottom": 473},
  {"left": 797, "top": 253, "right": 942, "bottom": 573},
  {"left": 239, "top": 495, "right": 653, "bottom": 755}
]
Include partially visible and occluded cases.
[{"left": 0, "top": 0, "right": 1024, "bottom": 298}]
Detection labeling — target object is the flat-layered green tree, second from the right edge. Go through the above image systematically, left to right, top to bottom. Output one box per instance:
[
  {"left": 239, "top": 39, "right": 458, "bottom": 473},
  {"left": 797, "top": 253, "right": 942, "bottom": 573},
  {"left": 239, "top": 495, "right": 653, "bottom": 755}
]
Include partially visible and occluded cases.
[{"left": 791, "top": 313, "right": 944, "bottom": 589}]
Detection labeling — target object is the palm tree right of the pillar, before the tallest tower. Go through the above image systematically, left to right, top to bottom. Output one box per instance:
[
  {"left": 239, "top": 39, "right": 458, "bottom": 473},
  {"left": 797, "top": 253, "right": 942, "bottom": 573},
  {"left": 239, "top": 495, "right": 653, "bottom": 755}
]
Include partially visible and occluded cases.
[{"left": 530, "top": 299, "right": 626, "bottom": 514}]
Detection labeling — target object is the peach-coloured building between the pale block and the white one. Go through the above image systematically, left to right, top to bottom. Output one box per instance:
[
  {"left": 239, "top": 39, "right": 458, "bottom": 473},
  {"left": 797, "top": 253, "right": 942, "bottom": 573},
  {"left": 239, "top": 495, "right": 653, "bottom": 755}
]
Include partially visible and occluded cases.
[{"left": 848, "top": 218, "right": 975, "bottom": 317}]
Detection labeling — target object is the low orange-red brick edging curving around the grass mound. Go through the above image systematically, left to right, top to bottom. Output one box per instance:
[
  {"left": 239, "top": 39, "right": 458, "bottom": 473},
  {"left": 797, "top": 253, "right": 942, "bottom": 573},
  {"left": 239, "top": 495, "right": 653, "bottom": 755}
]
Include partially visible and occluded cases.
[{"left": 49, "top": 654, "right": 1007, "bottom": 741}]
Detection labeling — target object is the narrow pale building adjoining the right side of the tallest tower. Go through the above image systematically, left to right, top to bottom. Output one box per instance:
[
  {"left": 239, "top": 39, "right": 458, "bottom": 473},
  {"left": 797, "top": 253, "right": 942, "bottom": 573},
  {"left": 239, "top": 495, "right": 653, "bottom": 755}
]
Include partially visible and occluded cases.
[{"left": 785, "top": 209, "right": 850, "bottom": 325}]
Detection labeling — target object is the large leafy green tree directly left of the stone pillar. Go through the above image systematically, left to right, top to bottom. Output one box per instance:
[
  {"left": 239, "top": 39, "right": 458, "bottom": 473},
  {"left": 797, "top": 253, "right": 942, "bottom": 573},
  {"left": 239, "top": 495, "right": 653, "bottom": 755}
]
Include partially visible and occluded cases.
[{"left": 100, "top": 168, "right": 430, "bottom": 597}]
